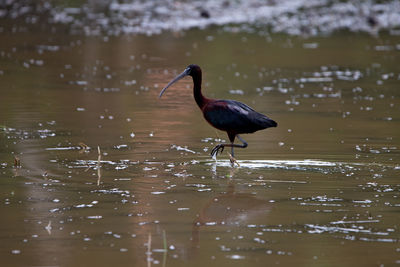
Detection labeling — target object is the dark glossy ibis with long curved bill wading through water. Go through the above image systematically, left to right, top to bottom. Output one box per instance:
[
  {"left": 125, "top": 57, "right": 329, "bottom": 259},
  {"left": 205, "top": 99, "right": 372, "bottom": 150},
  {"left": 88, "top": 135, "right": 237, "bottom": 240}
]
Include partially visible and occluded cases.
[{"left": 159, "top": 64, "right": 277, "bottom": 163}]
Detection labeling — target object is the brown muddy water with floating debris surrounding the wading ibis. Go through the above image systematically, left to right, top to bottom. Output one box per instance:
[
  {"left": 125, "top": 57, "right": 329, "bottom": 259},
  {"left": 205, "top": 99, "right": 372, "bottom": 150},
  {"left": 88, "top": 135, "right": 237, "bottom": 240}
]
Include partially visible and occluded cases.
[{"left": 0, "top": 24, "right": 400, "bottom": 266}]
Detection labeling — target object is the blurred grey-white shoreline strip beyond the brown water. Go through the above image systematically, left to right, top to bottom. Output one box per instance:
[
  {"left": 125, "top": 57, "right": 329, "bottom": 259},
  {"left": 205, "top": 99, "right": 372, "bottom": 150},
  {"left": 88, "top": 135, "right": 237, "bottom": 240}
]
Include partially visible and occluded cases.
[{"left": 0, "top": 0, "right": 400, "bottom": 36}]
